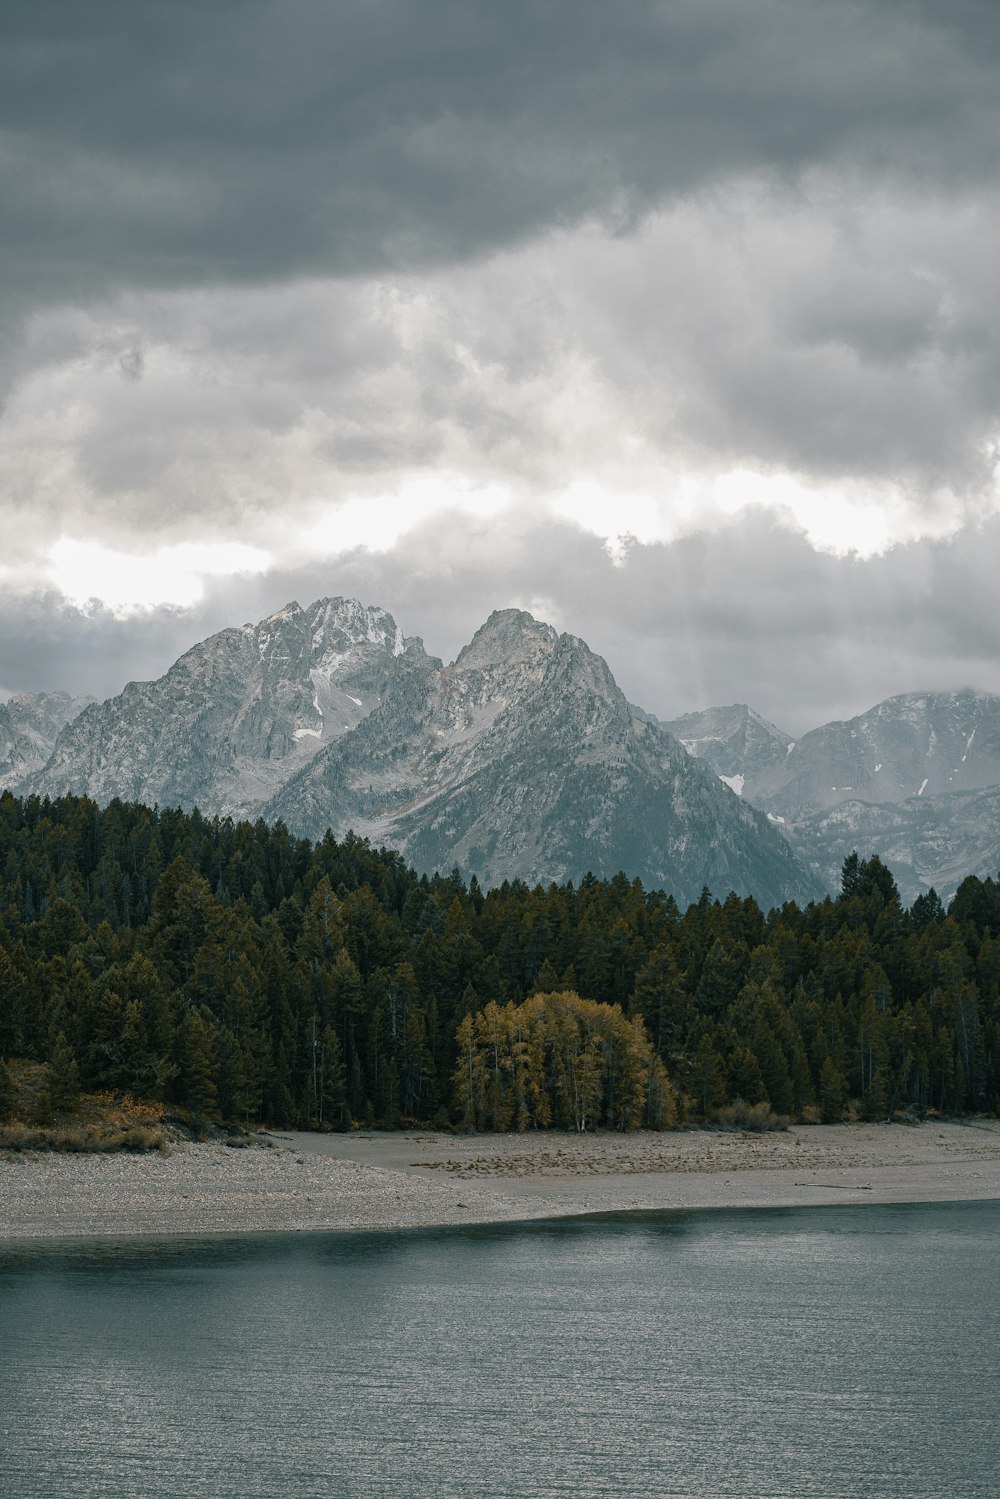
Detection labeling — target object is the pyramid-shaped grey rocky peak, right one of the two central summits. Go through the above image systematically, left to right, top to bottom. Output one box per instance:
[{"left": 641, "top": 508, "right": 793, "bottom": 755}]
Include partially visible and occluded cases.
[{"left": 265, "top": 610, "right": 811, "bottom": 904}]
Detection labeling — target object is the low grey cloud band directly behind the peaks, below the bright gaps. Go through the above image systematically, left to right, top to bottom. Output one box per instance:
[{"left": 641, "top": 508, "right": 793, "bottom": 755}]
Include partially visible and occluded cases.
[{"left": 0, "top": 516, "right": 1000, "bottom": 735}]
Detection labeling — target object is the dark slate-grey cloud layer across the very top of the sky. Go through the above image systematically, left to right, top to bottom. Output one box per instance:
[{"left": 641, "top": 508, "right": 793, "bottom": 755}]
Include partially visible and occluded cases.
[{"left": 0, "top": 0, "right": 1000, "bottom": 322}]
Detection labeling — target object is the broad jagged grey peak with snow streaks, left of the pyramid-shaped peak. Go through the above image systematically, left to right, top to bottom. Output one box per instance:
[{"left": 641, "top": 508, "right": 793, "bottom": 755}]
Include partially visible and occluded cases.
[{"left": 31, "top": 598, "right": 413, "bottom": 817}]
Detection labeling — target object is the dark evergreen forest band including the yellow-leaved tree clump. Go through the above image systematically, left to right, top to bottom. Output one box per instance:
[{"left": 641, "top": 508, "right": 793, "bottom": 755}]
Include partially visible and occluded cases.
[{"left": 0, "top": 793, "right": 1000, "bottom": 1130}]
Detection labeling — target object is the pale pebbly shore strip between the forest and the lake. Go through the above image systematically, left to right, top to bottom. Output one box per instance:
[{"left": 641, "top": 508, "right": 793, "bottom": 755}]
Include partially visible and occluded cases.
[{"left": 0, "top": 1120, "right": 1000, "bottom": 1240}]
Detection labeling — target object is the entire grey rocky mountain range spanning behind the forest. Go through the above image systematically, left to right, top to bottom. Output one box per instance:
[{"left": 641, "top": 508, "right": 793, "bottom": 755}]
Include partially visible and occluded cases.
[{"left": 0, "top": 598, "right": 1000, "bottom": 907}]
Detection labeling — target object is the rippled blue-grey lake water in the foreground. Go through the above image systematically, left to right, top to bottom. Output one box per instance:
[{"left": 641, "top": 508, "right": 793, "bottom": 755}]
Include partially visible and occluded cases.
[{"left": 0, "top": 1204, "right": 1000, "bottom": 1499}]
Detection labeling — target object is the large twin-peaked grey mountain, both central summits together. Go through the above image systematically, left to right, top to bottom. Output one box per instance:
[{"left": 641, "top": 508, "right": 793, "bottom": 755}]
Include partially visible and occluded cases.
[{"left": 18, "top": 598, "right": 819, "bottom": 907}]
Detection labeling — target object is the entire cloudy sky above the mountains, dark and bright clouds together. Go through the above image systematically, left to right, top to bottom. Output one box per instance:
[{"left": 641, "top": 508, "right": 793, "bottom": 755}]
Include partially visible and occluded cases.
[{"left": 0, "top": 0, "right": 1000, "bottom": 735}]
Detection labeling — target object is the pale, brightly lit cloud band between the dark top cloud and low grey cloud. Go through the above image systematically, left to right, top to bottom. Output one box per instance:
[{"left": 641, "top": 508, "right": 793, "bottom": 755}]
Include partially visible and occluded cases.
[{"left": 0, "top": 172, "right": 1000, "bottom": 609}]
